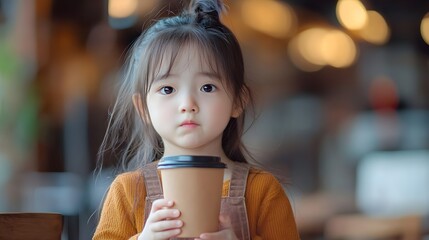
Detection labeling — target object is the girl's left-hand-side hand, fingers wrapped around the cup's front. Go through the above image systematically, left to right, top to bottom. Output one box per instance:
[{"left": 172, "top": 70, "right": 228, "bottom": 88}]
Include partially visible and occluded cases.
[{"left": 138, "top": 199, "right": 183, "bottom": 240}]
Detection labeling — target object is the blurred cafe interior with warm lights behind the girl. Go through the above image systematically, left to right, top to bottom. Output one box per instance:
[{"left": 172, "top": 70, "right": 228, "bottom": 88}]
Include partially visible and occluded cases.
[{"left": 0, "top": 0, "right": 429, "bottom": 240}]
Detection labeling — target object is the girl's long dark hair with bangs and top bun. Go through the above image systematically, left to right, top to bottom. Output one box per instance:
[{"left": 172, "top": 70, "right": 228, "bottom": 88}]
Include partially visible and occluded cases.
[{"left": 99, "top": 0, "right": 251, "bottom": 171}]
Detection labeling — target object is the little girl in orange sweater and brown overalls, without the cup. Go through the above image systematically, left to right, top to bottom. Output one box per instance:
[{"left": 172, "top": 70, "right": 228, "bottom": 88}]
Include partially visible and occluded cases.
[{"left": 93, "top": 0, "right": 299, "bottom": 240}]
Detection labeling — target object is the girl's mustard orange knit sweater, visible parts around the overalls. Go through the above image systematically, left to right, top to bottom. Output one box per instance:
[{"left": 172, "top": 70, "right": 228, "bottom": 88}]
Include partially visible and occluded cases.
[{"left": 93, "top": 169, "right": 299, "bottom": 240}]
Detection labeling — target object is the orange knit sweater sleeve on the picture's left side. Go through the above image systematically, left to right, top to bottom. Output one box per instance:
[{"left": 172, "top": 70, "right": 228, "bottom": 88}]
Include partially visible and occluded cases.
[{"left": 93, "top": 172, "right": 145, "bottom": 240}]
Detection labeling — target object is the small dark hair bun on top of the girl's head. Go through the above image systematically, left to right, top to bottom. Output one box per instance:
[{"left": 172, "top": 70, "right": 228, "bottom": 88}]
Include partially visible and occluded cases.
[{"left": 190, "top": 0, "right": 224, "bottom": 28}]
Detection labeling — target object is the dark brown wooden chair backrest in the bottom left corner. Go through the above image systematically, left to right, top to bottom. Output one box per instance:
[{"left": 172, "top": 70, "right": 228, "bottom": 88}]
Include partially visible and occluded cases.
[{"left": 0, "top": 213, "right": 63, "bottom": 240}]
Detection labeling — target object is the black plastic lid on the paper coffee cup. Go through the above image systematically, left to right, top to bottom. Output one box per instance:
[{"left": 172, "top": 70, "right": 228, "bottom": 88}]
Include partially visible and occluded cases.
[{"left": 158, "top": 155, "right": 226, "bottom": 169}]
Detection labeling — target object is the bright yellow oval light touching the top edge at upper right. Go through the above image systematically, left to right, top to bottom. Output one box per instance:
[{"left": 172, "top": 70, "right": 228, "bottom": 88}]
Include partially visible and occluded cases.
[{"left": 336, "top": 0, "right": 367, "bottom": 30}]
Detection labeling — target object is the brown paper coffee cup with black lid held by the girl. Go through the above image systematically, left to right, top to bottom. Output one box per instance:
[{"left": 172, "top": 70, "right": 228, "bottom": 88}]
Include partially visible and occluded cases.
[{"left": 158, "top": 155, "right": 226, "bottom": 238}]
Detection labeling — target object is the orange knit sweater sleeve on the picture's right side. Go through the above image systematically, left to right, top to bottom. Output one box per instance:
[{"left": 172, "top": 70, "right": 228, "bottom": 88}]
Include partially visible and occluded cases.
[{"left": 249, "top": 173, "right": 300, "bottom": 240}]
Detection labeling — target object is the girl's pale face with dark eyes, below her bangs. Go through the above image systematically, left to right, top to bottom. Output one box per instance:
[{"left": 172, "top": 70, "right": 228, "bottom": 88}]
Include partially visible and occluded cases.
[{"left": 146, "top": 46, "right": 239, "bottom": 156}]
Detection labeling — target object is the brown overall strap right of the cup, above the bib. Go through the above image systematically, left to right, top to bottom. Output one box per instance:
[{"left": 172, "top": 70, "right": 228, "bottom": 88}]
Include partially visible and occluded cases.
[{"left": 229, "top": 162, "right": 250, "bottom": 197}]
